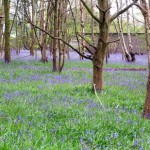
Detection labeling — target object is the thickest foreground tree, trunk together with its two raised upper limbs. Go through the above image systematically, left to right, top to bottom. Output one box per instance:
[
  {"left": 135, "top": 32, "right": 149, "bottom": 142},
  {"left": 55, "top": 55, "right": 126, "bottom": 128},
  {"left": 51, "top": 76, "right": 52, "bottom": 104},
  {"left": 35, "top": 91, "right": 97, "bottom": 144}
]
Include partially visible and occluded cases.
[{"left": 81, "top": 0, "right": 137, "bottom": 91}]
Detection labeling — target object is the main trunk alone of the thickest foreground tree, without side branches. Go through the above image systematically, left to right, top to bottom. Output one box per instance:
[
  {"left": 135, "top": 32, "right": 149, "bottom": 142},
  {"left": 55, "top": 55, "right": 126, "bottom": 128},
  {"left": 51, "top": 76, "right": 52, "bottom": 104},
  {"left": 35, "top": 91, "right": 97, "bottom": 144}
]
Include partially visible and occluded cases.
[{"left": 93, "top": 1, "right": 110, "bottom": 91}]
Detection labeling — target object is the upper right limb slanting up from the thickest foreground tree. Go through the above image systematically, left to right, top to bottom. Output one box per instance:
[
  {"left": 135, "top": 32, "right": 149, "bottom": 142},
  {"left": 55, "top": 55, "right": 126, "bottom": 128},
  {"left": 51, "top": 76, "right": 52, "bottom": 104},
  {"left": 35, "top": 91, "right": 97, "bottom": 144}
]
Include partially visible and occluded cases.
[{"left": 110, "top": 0, "right": 138, "bottom": 22}]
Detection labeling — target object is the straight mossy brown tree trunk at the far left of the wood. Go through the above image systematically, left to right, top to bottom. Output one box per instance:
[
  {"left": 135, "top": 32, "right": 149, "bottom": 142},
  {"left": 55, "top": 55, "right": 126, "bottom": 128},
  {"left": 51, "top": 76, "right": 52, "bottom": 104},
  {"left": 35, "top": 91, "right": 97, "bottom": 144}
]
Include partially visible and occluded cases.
[{"left": 3, "top": 0, "right": 11, "bottom": 63}]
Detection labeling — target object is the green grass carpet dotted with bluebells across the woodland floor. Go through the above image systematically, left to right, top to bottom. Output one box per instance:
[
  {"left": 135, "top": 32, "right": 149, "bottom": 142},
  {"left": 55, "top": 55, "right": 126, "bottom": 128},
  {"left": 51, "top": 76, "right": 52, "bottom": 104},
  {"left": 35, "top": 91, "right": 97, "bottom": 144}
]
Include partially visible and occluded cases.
[{"left": 0, "top": 61, "right": 150, "bottom": 150}]
